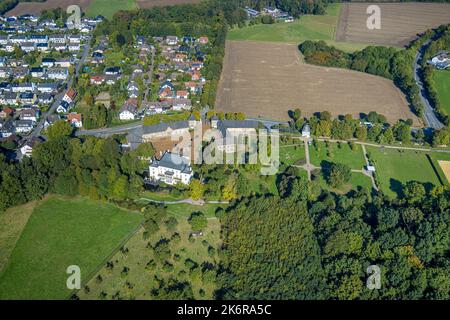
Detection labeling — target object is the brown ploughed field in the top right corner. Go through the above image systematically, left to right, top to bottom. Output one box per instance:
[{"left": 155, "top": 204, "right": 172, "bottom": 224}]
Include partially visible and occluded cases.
[{"left": 336, "top": 3, "right": 450, "bottom": 46}]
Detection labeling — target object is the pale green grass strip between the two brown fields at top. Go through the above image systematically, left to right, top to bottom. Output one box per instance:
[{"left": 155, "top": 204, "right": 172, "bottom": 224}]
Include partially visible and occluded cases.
[{"left": 228, "top": 3, "right": 367, "bottom": 51}]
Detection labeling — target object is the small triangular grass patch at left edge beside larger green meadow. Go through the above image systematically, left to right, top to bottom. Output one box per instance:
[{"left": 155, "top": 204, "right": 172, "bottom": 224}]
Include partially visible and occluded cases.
[{"left": 0, "top": 201, "right": 36, "bottom": 273}]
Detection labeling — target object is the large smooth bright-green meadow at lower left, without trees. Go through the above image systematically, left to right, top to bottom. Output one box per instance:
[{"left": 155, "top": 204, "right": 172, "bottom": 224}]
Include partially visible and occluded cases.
[{"left": 0, "top": 196, "right": 142, "bottom": 299}]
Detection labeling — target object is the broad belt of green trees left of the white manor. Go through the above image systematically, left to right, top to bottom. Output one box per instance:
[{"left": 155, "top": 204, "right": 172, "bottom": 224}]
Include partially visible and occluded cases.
[{"left": 0, "top": 120, "right": 154, "bottom": 211}]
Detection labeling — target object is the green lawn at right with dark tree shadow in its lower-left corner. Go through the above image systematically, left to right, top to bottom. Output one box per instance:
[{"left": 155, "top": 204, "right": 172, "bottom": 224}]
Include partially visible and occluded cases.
[{"left": 366, "top": 147, "right": 440, "bottom": 196}]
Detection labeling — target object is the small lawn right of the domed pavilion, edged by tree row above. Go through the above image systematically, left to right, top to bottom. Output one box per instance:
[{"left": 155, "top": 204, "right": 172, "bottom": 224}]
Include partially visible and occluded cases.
[{"left": 309, "top": 141, "right": 366, "bottom": 170}]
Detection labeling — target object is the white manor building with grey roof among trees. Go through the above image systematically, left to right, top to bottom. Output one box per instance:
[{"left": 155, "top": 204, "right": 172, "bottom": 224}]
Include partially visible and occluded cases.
[{"left": 149, "top": 152, "right": 194, "bottom": 185}]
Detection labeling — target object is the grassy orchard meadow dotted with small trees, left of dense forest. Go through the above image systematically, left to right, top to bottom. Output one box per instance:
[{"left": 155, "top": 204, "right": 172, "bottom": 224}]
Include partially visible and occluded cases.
[{"left": 78, "top": 206, "right": 220, "bottom": 299}]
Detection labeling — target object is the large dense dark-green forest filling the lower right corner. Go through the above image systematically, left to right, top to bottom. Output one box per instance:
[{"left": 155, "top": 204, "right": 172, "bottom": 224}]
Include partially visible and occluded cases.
[{"left": 217, "top": 175, "right": 450, "bottom": 299}]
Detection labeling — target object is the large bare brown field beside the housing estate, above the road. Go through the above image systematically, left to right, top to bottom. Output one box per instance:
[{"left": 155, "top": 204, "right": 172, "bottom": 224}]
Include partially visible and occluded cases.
[{"left": 216, "top": 41, "right": 417, "bottom": 124}]
